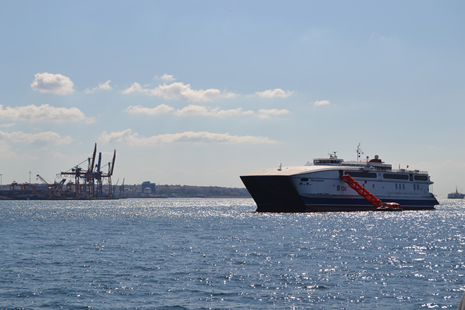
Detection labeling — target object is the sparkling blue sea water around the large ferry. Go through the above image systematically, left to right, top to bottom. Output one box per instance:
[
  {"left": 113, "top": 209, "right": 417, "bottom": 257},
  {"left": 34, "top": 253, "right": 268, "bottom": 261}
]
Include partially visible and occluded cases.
[{"left": 0, "top": 198, "right": 465, "bottom": 309}]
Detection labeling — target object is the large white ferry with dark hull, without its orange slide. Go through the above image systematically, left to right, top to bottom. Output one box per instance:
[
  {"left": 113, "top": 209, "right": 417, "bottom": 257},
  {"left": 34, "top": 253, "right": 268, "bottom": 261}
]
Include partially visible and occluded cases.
[{"left": 240, "top": 149, "right": 439, "bottom": 212}]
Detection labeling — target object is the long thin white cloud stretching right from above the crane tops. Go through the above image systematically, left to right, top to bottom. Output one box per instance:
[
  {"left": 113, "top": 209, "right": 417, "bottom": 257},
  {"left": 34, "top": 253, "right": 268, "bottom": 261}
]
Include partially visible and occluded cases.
[{"left": 99, "top": 129, "right": 278, "bottom": 146}]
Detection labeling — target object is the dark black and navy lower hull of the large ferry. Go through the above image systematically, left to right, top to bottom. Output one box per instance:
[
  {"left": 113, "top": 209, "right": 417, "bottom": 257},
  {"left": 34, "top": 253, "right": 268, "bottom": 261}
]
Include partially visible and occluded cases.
[{"left": 241, "top": 175, "right": 439, "bottom": 212}]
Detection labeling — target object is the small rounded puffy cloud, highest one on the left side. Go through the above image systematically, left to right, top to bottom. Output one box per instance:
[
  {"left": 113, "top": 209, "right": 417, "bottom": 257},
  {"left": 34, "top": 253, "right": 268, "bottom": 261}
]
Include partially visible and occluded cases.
[{"left": 31, "top": 72, "right": 74, "bottom": 95}]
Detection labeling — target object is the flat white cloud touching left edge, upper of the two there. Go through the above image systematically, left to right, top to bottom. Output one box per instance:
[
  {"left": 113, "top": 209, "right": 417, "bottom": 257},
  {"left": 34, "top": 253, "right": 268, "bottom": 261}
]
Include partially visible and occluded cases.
[{"left": 0, "top": 104, "right": 95, "bottom": 123}]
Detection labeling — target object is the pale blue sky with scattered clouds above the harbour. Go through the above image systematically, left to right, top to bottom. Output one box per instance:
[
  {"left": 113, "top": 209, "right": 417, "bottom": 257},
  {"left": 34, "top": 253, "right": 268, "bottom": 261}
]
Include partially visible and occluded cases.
[{"left": 0, "top": 0, "right": 465, "bottom": 196}]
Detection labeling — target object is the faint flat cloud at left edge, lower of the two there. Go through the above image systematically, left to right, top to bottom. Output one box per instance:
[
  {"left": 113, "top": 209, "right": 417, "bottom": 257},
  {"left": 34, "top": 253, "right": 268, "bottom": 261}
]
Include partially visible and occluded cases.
[{"left": 0, "top": 131, "right": 73, "bottom": 145}]
